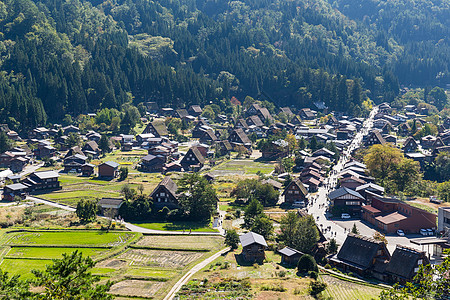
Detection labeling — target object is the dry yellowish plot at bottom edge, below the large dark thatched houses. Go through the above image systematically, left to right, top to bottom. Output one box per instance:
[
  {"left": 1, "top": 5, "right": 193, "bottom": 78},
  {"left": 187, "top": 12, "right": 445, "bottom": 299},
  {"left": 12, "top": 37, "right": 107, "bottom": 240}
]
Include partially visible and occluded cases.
[{"left": 321, "top": 275, "right": 382, "bottom": 300}]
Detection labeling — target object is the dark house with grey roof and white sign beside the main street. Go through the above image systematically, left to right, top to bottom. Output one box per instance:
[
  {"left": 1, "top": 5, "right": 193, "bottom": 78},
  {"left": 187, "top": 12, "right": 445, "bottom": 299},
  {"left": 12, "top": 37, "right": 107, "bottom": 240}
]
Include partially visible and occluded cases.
[{"left": 328, "top": 187, "right": 365, "bottom": 215}]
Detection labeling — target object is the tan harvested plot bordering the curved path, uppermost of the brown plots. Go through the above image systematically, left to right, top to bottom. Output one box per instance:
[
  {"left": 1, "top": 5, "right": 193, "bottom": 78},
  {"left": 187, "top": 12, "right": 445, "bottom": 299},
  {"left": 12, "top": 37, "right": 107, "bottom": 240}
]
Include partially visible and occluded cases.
[{"left": 136, "top": 235, "right": 223, "bottom": 250}]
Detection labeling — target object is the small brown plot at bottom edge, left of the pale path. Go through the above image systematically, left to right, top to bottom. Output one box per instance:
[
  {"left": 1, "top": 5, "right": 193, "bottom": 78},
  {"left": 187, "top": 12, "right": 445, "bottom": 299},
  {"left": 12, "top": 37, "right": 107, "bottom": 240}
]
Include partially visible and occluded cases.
[{"left": 110, "top": 280, "right": 164, "bottom": 298}]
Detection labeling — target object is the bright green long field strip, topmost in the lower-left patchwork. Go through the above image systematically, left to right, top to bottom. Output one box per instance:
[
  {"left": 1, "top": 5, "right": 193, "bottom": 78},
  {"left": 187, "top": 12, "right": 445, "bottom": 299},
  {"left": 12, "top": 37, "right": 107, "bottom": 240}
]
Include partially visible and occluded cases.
[{"left": 7, "top": 231, "right": 135, "bottom": 247}]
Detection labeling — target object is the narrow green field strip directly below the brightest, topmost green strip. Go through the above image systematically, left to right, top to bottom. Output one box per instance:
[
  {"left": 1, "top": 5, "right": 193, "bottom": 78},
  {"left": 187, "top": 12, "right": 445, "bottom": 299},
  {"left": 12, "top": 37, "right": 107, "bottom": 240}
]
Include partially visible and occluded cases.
[{"left": 5, "top": 247, "right": 107, "bottom": 259}]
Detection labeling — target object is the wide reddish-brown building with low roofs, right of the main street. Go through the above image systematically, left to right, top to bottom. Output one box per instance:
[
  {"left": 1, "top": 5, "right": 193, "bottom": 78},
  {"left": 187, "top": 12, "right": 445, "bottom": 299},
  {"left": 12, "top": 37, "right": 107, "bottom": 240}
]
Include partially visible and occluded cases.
[{"left": 362, "top": 191, "right": 437, "bottom": 234}]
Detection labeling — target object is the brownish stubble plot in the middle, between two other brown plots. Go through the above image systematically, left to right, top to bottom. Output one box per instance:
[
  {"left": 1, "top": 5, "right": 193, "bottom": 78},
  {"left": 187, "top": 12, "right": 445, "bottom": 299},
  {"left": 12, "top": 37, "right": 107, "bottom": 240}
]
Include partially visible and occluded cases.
[{"left": 118, "top": 249, "right": 203, "bottom": 269}]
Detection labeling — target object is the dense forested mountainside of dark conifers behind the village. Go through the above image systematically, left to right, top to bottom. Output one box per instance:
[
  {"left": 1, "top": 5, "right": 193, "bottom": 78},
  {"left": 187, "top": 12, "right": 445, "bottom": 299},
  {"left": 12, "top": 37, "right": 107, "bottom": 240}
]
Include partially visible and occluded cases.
[{"left": 0, "top": 0, "right": 450, "bottom": 129}]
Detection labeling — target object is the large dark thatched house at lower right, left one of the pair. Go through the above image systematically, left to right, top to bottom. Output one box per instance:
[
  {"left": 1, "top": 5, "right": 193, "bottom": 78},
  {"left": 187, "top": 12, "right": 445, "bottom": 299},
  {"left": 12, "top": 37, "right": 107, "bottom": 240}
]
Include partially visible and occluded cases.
[{"left": 330, "top": 233, "right": 391, "bottom": 280}]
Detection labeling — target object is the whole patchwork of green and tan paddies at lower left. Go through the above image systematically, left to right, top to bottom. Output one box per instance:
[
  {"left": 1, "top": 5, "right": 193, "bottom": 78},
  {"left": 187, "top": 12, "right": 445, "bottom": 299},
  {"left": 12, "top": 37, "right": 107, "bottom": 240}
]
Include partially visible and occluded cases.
[{"left": 0, "top": 229, "right": 224, "bottom": 299}]
